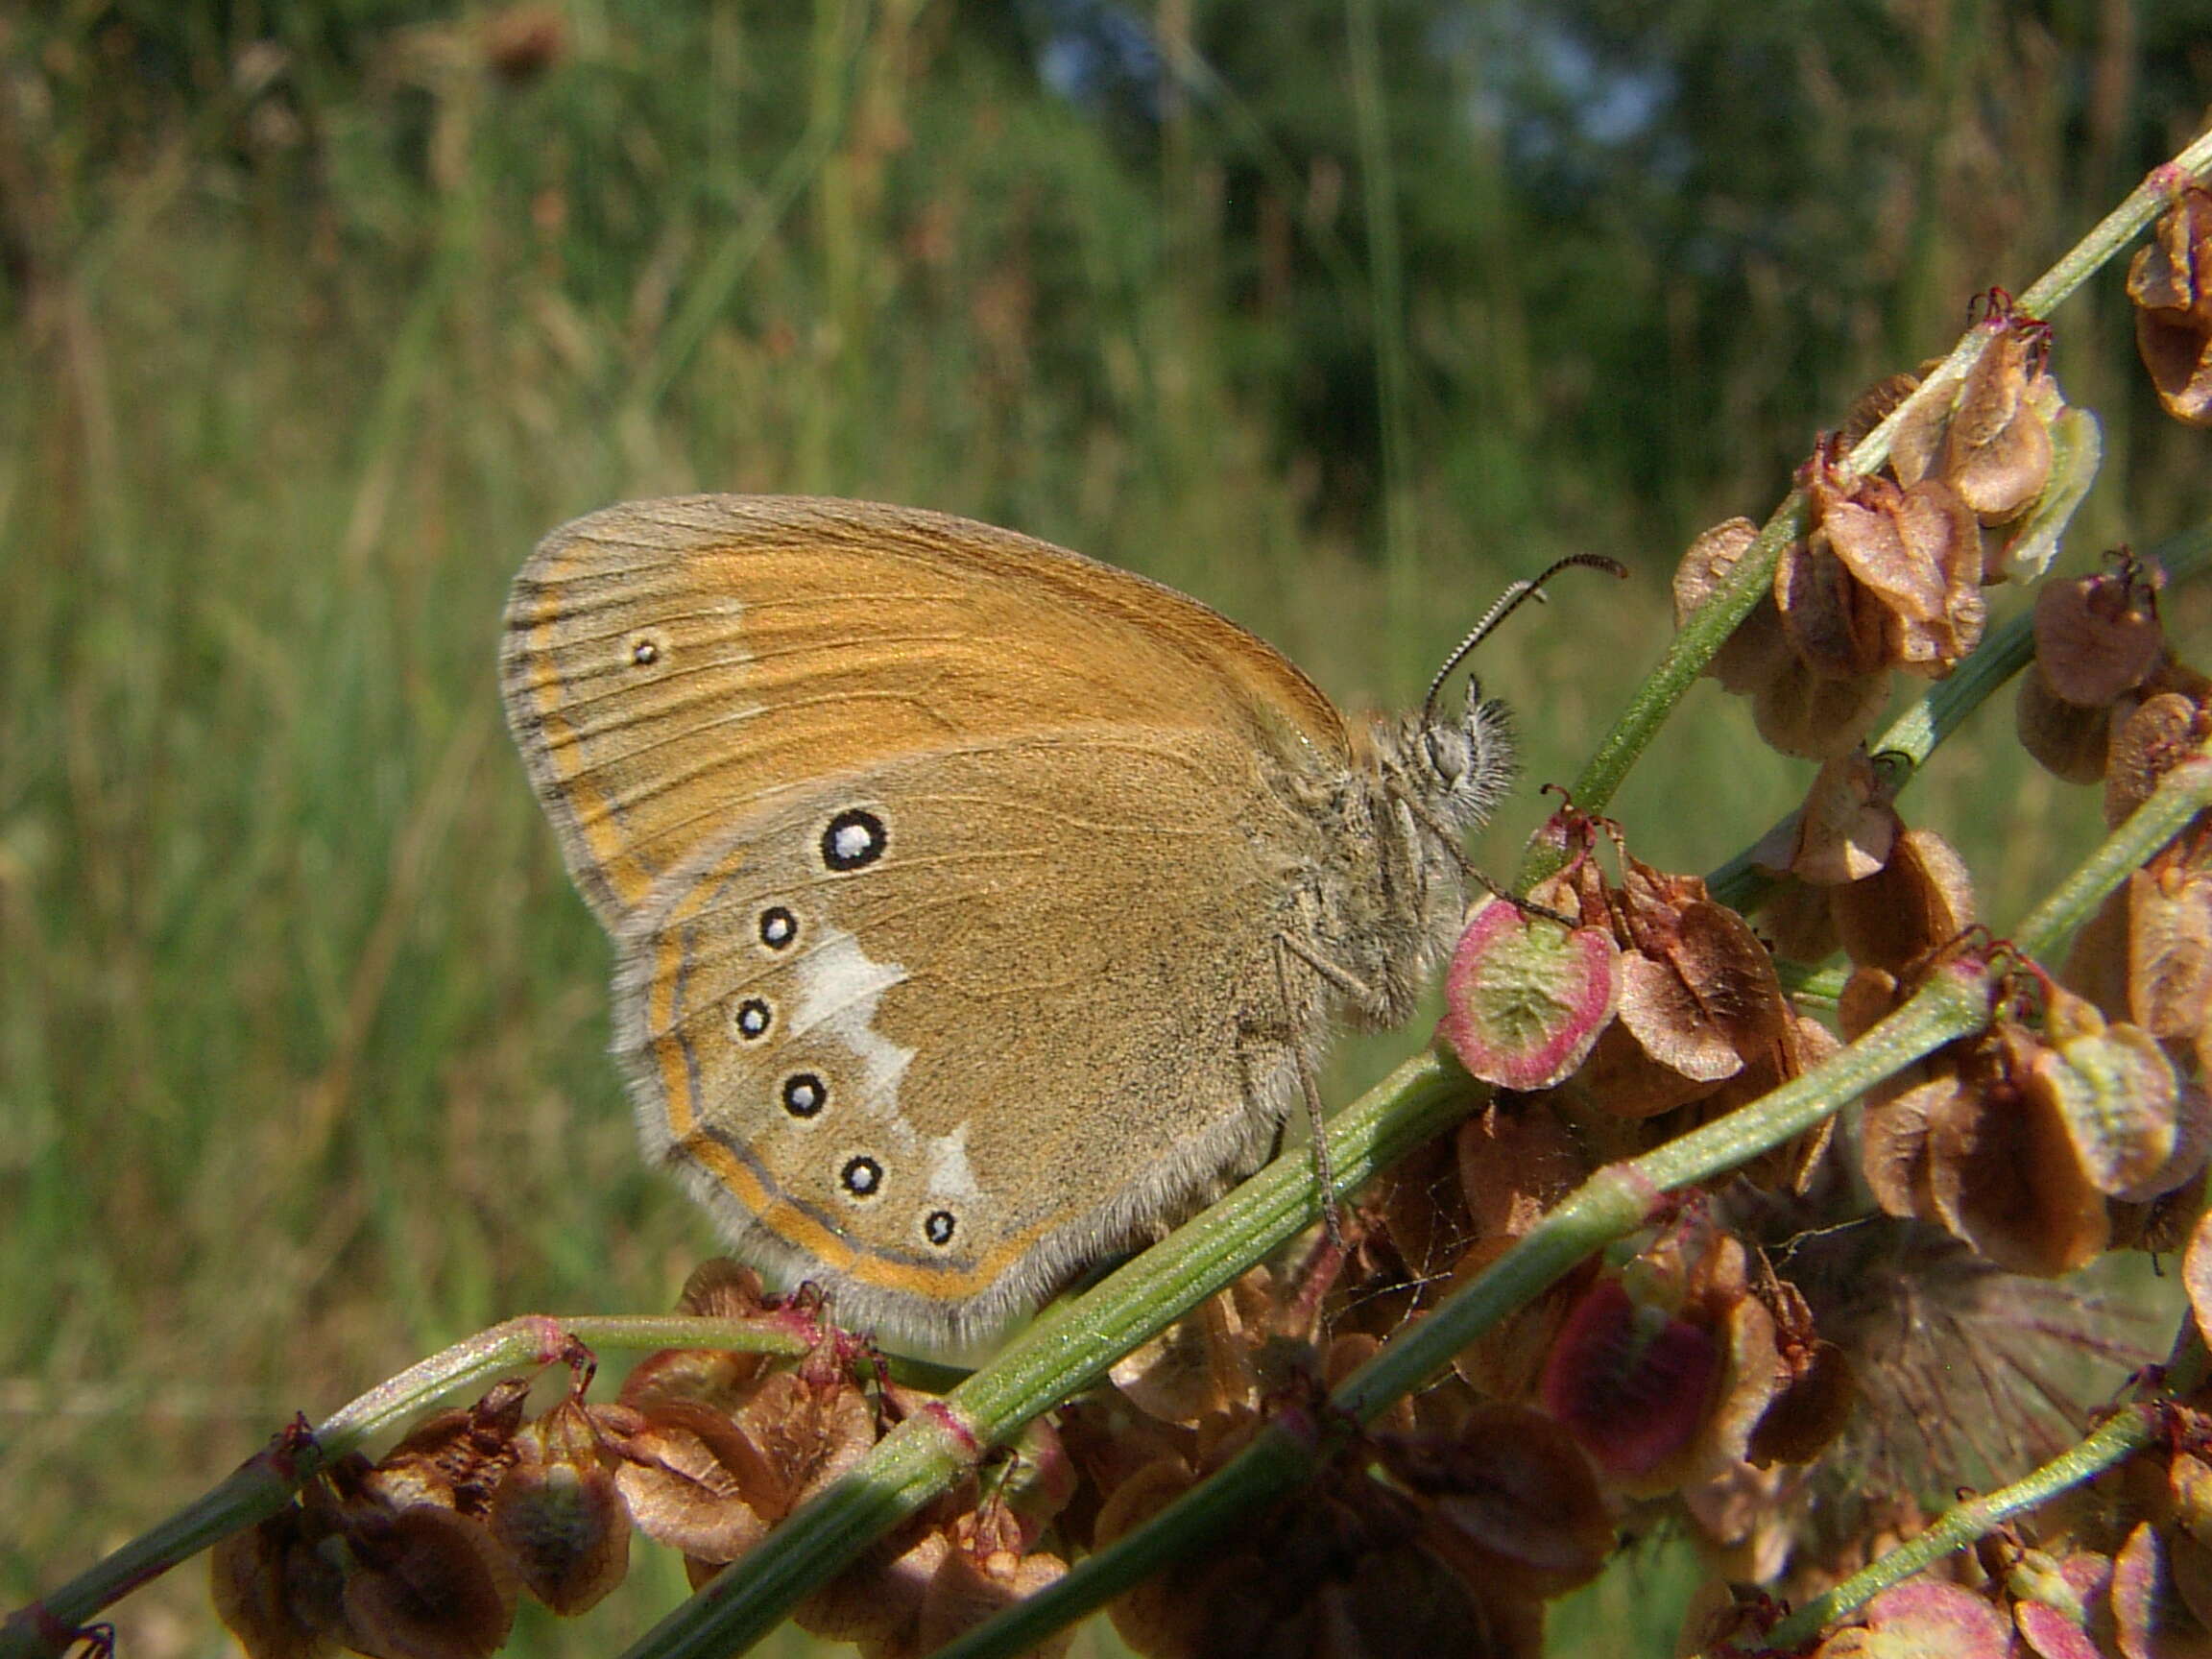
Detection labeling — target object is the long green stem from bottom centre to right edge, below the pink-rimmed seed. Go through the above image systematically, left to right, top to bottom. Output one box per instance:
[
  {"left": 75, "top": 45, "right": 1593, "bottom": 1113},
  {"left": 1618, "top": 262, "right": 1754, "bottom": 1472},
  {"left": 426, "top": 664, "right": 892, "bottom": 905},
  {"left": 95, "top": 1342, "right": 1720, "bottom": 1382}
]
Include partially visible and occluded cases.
[{"left": 938, "top": 738, "right": 2212, "bottom": 1659}]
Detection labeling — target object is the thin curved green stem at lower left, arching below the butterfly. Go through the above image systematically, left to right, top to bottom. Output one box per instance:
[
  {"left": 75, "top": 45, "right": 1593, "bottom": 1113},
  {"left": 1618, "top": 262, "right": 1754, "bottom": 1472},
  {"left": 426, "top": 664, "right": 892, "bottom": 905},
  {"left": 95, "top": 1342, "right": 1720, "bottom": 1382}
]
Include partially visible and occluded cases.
[{"left": 0, "top": 1314, "right": 807, "bottom": 1659}]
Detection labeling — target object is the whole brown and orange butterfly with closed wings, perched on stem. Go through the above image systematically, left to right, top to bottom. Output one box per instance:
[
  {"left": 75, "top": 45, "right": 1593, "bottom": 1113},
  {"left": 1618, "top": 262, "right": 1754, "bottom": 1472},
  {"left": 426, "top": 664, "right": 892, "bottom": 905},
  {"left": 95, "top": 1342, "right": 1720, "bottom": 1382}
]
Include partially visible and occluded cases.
[{"left": 502, "top": 495, "right": 1533, "bottom": 1356}]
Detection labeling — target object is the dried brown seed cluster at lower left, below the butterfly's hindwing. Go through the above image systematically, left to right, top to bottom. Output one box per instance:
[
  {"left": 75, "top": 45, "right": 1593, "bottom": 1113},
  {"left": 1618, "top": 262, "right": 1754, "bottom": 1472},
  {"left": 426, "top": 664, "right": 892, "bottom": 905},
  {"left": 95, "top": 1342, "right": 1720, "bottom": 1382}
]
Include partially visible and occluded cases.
[{"left": 212, "top": 1261, "right": 1070, "bottom": 1659}]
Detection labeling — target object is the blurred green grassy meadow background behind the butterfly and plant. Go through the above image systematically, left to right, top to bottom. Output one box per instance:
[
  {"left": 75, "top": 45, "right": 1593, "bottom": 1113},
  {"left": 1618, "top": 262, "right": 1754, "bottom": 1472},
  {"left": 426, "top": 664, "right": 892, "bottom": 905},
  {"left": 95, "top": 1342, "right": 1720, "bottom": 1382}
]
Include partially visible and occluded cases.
[{"left": 0, "top": 0, "right": 2212, "bottom": 1659}]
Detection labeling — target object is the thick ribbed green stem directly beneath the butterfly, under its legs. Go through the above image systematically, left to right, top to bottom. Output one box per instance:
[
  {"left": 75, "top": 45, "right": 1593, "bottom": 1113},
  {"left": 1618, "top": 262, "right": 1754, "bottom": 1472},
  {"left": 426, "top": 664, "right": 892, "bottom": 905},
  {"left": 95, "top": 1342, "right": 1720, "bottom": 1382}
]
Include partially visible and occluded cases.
[{"left": 626, "top": 1053, "right": 1476, "bottom": 1659}]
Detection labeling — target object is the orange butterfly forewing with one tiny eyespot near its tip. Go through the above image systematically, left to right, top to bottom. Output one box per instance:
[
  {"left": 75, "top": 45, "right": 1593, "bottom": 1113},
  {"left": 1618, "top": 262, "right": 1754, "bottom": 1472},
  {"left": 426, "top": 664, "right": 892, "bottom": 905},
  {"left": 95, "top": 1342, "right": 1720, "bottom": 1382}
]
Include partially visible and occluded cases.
[{"left": 502, "top": 495, "right": 1347, "bottom": 926}]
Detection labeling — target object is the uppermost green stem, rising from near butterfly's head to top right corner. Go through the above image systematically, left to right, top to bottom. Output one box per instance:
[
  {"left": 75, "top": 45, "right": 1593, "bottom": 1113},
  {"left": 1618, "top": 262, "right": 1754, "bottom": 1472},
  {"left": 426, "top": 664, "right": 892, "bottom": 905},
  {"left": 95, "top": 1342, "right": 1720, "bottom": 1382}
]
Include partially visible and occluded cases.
[{"left": 1515, "top": 132, "right": 2212, "bottom": 892}]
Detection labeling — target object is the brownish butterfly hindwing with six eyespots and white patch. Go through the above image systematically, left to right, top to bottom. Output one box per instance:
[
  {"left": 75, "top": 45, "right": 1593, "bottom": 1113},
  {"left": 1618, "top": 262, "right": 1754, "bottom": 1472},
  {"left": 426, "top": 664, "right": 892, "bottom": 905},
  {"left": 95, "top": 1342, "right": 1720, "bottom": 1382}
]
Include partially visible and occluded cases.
[{"left": 617, "top": 728, "right": 1314, "bottom": 1334}]
